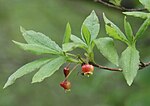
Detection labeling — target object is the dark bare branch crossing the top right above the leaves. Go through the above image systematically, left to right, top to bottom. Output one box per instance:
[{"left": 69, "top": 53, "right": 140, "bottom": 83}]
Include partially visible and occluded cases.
[{"left": 94, "top": 0, "right": 147, "bottom": 11}]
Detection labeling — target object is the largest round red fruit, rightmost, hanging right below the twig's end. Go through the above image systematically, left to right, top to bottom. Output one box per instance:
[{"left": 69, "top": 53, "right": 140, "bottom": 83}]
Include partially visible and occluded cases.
[{"left": 82, "top": 64, "right": 94, "bottom": 76}]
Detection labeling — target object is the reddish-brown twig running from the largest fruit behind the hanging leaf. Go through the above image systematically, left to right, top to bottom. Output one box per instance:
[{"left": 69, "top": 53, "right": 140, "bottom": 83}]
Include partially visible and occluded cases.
[{"left": 89, "top": 62, "right": 150, "bottom": 72}]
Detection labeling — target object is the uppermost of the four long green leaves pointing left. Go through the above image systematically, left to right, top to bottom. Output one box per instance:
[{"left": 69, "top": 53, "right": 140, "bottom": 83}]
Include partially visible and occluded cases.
[{"left": 20, "top": 27, "right": 62, "bottom": 52}]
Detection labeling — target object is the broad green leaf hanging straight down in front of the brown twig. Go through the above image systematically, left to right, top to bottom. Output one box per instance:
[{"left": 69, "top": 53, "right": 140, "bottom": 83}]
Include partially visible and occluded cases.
[{"left": 120, "top": 46, "right": 140, "bottom": 86}]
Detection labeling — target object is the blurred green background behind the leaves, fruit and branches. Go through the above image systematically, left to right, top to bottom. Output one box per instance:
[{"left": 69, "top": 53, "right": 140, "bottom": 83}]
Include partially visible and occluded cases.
[{"left": 0, "top": 0, "right": 150, "bottom": 106}]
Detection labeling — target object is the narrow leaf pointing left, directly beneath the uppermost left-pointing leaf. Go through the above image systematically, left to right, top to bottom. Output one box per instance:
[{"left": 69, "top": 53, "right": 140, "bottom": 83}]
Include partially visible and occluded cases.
[{"left": 13, "top": 41, "right": 60, "bottom": 55}]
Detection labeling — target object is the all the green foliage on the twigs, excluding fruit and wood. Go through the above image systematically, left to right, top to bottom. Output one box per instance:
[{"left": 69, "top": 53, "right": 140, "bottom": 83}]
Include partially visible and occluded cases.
[{"left": 4, "top": 0, "right": 150, "bottom": 88}]
